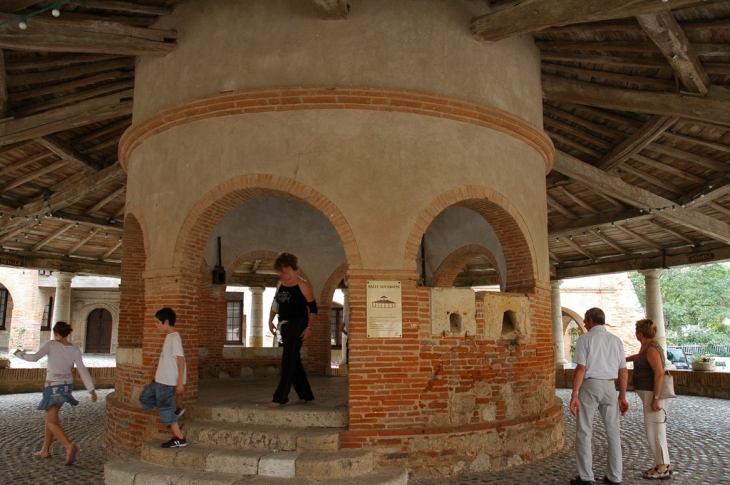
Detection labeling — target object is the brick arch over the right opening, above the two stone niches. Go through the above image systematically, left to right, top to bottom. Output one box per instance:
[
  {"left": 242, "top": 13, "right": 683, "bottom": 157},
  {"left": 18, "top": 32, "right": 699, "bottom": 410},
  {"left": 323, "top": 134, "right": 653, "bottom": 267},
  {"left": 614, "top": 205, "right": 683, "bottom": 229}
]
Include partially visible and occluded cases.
[{"left": 403, "top": 186, "right": 538, "bottom": 291}]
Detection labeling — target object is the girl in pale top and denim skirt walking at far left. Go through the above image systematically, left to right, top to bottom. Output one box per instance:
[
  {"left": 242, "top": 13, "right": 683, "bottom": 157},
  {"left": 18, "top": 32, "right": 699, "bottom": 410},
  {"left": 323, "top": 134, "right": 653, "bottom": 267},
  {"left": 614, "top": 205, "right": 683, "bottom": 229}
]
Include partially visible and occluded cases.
[{"left": 15, "top": 322, "right": 97, "bottom": 465}]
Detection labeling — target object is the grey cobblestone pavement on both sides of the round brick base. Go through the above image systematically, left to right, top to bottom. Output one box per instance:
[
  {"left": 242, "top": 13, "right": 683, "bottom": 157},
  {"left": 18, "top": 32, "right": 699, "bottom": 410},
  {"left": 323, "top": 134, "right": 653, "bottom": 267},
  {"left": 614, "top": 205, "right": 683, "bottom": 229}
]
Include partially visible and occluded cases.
[{"left": 0, "top": 389, "right": 730, "bottom": 485}]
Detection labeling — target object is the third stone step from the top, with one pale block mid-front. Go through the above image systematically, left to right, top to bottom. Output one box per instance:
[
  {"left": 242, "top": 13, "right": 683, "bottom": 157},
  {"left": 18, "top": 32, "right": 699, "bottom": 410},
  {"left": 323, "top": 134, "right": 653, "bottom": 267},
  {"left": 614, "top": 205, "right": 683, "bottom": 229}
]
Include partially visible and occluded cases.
[{"left": 140, "top": 441, "right": 373, "bottom": 479}]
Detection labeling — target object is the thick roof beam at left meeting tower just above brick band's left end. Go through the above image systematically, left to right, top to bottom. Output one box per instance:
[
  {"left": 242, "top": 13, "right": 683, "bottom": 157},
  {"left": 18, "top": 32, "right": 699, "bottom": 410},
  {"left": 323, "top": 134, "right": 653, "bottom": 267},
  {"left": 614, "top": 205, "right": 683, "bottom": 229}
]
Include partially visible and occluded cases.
[{"left": 0, "top": 90, "right": 134, "bottom": 146}]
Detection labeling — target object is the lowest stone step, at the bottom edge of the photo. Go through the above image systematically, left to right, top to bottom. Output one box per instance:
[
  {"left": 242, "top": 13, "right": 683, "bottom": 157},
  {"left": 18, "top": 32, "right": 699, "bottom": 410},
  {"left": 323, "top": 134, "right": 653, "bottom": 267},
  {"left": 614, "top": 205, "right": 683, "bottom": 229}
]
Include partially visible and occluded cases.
[{"left": 104, "top": 459, "right": 408, "bottom": 485}]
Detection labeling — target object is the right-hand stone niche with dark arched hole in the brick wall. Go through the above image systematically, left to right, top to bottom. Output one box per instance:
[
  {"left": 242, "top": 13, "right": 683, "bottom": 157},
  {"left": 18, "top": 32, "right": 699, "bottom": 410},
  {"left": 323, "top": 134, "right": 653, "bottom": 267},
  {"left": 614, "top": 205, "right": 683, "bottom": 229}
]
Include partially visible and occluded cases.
[{"left": 477, "top": 291, "right": 530, "bottom": 339}]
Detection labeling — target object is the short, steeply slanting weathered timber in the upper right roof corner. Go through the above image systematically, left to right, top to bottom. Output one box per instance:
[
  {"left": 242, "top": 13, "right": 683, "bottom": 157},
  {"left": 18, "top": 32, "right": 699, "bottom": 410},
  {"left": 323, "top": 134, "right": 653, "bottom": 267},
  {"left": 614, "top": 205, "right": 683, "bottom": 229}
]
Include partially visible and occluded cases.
[{"left": 636, "top": 10, "right": 710, "bottom": 95}]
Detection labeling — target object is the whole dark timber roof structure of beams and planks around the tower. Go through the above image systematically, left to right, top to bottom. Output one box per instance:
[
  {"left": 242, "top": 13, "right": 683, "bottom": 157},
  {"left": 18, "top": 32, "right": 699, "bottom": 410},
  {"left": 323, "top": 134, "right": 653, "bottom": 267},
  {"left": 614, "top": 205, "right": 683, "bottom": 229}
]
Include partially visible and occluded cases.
[{"left": 0, "top": 0, "right": 730, "bottom": 286}]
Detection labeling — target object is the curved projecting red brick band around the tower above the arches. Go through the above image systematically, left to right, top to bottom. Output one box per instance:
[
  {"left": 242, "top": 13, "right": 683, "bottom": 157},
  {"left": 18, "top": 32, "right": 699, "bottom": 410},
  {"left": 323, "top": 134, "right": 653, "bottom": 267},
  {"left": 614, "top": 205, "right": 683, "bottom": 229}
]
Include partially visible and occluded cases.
[{"left": 119, "top": 86, "right": 555, "bottom": 175}]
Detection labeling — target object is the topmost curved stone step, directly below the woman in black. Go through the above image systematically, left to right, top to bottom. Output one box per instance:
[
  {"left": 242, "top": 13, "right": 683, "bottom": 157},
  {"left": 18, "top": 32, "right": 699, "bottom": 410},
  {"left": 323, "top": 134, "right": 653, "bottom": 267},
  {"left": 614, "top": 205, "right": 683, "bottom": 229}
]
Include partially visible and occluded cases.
[{"left": 185, "top": 403, "right": 348, "bottom": 428}]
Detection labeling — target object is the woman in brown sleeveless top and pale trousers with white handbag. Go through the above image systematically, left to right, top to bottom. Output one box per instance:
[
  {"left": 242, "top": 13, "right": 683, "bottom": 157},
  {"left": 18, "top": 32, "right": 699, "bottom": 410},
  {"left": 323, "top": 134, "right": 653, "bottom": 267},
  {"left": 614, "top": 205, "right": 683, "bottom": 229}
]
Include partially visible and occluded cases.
[{"left": 626, "top": 318, "right": 672, "bottom": 480}]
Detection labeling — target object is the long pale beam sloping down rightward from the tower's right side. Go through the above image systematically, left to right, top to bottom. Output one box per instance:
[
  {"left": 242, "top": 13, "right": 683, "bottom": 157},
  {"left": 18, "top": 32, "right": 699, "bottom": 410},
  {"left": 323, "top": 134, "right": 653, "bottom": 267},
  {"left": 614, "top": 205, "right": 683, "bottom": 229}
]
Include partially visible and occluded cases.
[{"left": 554, "top": 151, "right": 730, "bottom": 244}]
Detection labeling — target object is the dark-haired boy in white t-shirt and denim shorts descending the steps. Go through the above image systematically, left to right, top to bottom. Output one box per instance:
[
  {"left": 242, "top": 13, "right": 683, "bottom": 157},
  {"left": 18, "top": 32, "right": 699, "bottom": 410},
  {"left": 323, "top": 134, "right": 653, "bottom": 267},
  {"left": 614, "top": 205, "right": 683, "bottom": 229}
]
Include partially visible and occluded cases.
[{"left": 139, "top": 308, "right": 188, "bottom": 448}]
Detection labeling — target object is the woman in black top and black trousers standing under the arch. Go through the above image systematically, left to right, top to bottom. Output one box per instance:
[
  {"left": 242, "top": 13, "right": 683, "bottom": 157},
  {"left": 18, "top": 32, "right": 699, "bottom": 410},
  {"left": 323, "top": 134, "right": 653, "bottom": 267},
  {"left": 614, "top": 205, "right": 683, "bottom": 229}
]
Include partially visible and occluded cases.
[{"left": 269, "top": 253, "right": 317, "bottom": 408}]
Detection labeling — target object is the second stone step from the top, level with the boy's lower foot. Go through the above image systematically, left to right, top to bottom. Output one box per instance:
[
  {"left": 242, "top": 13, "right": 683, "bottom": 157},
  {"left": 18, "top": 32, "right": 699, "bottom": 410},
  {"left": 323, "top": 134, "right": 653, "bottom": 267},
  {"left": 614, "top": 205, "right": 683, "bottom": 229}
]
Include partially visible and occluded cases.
[{"left": 181, "top": 420, "right": 344, "bottom": 451}]
